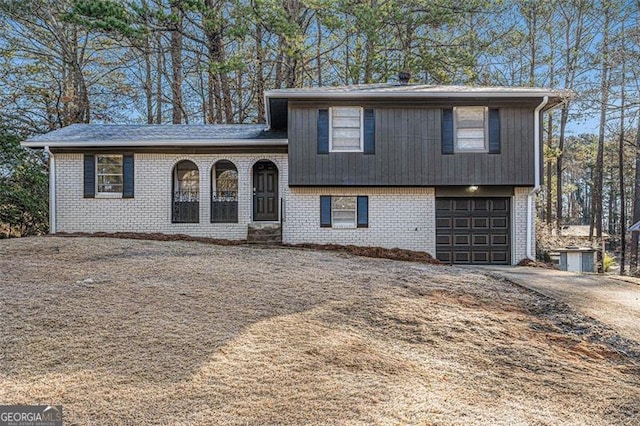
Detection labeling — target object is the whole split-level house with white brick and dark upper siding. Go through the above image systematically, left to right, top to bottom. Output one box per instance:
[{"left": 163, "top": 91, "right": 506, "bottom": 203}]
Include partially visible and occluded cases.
[{"left": 23, "top": 84, "right": 564, "bottom": 264}]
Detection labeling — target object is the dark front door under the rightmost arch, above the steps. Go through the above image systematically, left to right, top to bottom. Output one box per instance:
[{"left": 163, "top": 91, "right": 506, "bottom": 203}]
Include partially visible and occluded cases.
[{"left": 253, "top": 161, "right": 278, "bottom": 220}]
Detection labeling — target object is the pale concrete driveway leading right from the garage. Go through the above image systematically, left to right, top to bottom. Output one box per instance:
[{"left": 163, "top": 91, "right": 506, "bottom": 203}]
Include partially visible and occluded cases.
[{"left": 482, "top": 266, "right": 640, "bottom": 342}]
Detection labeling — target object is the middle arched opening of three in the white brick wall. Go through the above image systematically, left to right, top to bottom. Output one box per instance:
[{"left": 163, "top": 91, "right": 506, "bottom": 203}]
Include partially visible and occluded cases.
[{"left": 211, "top": 160, "right": 238, "bottom": 223}]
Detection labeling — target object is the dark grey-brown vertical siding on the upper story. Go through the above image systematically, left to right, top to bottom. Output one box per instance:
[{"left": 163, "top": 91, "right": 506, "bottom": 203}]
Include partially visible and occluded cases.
[{"left": 289, "top": 102, "right": 537, "bottom": 186}]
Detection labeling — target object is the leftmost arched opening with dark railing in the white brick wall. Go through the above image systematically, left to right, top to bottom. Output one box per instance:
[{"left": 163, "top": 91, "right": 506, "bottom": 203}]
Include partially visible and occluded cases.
[{"left": 171, "top": 160, "right": 200, "bottom": 223}]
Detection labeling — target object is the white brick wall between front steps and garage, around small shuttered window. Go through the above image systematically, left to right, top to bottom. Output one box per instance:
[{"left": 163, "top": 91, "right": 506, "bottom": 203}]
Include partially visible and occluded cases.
[{"left": 283, "top": 187, "right": 435, "bottom": 255}]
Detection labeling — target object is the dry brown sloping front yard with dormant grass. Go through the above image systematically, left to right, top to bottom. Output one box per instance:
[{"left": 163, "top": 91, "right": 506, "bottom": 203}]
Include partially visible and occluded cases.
[{"left": 0, "top": 237, "right": 640, "bottom": 425}]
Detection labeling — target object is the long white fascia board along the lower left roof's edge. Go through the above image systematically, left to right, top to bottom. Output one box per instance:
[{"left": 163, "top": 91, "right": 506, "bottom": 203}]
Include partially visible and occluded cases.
[{"left": 21, "top": 139, "right": 288, "bottom": 148}]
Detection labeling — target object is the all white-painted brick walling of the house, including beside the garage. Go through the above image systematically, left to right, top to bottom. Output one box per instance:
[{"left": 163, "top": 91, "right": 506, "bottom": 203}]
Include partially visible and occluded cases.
[{"left": 55, "top": 154, "right": 535, "bottom": 264}]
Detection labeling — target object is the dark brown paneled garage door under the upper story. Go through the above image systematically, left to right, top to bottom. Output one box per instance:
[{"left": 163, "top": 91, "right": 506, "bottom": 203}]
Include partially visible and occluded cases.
[{"left": 436, "top": 198, "right": 511, "bottom": 264}]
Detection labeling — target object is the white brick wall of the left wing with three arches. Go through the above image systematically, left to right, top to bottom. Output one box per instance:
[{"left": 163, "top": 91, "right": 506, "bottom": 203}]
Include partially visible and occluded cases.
[{"left": 55, "top": 154, "right": 288, "bottom": 239}]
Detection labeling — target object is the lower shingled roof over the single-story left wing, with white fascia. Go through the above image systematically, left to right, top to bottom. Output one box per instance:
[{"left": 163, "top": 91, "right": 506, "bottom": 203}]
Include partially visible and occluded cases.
[{"left": 22, "top": 124, "right": 287, "bottom": 148}]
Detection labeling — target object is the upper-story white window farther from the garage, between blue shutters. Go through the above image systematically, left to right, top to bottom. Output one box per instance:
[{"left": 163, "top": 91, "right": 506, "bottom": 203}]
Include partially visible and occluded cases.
[{"left": 329, "top": 107, "right": 363, "bottom": 152}]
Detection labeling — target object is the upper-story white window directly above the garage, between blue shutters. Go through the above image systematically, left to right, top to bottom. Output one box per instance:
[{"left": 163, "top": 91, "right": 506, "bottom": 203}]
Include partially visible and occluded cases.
[{"left": 453, "top": 106, "right": 488, "bottom": 152}]
